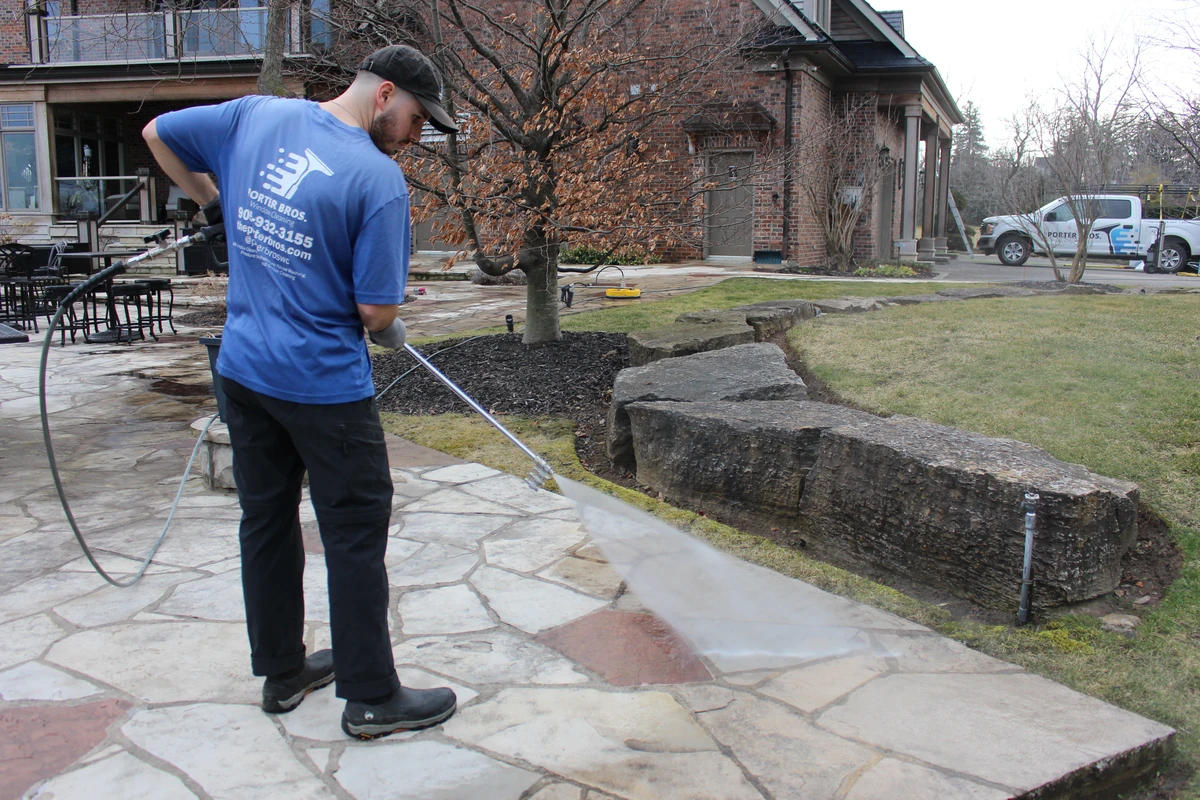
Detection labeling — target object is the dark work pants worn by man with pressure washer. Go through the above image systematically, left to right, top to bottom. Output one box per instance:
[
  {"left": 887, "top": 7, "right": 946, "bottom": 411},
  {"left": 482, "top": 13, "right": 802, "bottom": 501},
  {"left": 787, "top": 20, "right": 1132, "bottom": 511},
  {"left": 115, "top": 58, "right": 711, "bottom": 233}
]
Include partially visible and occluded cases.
[{"left": 222, "top": 378, "right": 400, "bottom": 699}]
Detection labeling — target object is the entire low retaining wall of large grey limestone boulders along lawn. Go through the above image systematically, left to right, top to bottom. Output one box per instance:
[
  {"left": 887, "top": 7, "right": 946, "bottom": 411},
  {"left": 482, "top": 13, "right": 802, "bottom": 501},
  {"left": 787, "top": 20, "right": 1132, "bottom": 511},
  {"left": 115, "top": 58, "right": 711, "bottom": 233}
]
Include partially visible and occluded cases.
[{"left": 608, "top": 288, "right": 1138, "bottom": 609}]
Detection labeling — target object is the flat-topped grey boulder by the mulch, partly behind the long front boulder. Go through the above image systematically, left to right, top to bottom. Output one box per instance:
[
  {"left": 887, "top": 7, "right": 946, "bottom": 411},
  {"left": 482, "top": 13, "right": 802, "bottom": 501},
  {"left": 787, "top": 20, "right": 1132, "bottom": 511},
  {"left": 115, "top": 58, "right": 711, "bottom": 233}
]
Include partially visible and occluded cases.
[{"left": 607, "top": 343, "right": 808, "bottom": 471}]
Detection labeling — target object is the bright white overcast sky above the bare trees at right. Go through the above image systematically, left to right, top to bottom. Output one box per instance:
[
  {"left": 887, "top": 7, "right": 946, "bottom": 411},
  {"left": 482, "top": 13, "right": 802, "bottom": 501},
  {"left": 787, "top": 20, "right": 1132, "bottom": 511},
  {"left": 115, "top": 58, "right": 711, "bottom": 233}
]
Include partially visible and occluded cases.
[{"left": 892, "top": 0, "right": 1200, "bottom": 145}]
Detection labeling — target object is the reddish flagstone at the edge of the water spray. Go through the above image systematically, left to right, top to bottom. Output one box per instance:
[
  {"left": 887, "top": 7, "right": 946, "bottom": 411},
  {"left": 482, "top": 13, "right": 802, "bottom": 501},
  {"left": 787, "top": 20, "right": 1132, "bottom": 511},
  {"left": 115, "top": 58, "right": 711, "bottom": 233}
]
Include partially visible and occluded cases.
[{"left": 536, "top": 609, "right": 713, "bottom": 686}]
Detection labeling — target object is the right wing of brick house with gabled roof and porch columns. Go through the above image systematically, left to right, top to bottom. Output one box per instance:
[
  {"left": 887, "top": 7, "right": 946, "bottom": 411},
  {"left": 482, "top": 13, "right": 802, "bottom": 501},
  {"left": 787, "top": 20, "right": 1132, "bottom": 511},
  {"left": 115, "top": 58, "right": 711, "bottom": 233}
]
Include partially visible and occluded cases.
[{"left": 670, "top": 0, "right": 962, "bottom": 265}]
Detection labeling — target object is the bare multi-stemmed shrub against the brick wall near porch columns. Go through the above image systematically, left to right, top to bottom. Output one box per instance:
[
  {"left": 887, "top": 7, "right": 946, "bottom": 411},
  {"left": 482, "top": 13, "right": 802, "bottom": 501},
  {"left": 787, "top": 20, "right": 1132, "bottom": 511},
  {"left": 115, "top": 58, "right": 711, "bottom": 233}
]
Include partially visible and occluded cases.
[{"left": 792, "top": 95, "right": 887, "bottom": 272}]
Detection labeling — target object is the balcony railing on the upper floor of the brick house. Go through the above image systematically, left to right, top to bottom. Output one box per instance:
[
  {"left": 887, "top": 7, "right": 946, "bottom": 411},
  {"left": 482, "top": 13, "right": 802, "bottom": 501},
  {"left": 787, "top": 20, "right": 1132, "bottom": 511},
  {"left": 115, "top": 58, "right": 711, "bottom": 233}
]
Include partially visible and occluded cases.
[{"left": 30, "top": 6, "right": 299, "bottom": 64}]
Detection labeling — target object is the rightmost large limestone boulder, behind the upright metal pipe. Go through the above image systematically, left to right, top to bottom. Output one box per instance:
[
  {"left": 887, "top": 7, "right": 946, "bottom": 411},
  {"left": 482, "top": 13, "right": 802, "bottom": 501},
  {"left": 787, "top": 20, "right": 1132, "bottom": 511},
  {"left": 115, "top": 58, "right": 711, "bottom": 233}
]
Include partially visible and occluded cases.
[{"left": 801, "top": 417, "right": 1139, "bottom": 609}]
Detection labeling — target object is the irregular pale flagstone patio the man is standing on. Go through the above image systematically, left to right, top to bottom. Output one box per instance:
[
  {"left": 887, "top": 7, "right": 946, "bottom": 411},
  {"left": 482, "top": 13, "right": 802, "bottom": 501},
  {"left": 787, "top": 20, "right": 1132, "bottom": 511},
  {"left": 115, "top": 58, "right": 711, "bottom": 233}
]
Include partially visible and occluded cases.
[{"left": 0, "top": 339, "right": 1172, "bottom": 800}]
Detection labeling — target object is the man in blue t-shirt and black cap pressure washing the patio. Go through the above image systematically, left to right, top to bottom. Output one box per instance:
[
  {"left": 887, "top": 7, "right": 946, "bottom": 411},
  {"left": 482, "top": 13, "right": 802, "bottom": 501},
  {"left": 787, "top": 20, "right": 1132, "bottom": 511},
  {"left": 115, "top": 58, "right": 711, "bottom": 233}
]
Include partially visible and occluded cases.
[{"left": 143, "top": 46, "right": 456, "bottom": 738}]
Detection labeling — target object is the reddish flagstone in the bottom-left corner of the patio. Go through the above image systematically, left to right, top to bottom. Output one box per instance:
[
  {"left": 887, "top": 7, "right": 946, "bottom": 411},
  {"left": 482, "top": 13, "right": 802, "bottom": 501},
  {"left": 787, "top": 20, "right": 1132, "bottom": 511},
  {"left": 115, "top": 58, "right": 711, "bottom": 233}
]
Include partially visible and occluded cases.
[{"left": 0, "top": 700, "right": 130, "bottom": 800}]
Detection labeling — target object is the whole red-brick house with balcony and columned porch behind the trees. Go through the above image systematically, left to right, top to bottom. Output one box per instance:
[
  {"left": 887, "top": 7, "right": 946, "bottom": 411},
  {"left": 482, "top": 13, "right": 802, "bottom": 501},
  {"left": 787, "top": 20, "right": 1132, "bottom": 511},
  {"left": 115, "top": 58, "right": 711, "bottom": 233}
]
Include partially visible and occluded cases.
[{"left": 0, "top": 0, "right": 962, "bottom": 265}]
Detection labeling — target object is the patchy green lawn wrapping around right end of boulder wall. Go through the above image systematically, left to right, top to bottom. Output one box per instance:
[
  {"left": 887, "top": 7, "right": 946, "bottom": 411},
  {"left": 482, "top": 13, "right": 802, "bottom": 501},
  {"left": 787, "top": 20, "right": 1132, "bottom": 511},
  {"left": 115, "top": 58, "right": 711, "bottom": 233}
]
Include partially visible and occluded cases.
[{"left": 790, "top": 295, "right": 1200, "bottom": 796}]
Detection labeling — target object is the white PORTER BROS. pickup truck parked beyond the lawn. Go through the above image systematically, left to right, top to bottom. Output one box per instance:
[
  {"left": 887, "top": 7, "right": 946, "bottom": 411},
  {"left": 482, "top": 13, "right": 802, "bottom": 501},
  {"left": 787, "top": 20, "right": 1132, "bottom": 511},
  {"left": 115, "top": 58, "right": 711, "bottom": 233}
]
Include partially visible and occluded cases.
[{"left": 976, "top": 194, "right": 1200, "bottom": 272}]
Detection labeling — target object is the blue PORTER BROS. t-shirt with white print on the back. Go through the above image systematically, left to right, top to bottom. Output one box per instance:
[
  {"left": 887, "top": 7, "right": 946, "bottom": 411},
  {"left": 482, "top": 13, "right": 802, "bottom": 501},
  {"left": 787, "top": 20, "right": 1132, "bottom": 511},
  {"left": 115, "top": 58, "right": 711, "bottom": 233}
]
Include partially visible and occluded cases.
[{"left": 157, "top": 96, "right": 410, "bottom": 404}]
